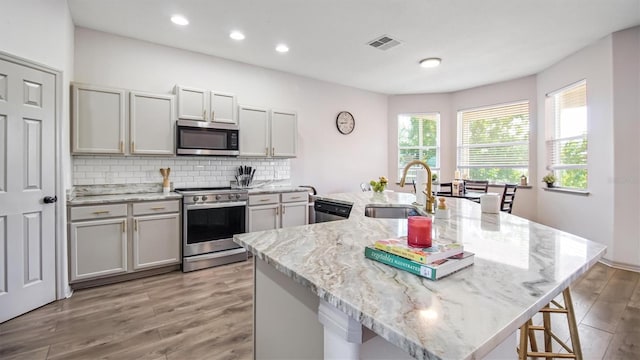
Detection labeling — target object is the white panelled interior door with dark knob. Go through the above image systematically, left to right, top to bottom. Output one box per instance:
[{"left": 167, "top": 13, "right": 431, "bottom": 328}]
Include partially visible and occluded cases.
[{"left": 0, "top": 59, "right": 56, "bottom": 322}]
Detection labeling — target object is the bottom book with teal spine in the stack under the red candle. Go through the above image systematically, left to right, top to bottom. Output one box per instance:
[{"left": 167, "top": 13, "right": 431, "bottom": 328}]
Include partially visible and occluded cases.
[{"left": 364, "top": 246, "right": 475, "bottom": 280}]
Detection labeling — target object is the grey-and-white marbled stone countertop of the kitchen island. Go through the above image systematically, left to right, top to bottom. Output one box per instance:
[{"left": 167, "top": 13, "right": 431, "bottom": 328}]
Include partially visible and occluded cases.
[{"left": 234, "top": 192, "right": 605, "bottom": 359}]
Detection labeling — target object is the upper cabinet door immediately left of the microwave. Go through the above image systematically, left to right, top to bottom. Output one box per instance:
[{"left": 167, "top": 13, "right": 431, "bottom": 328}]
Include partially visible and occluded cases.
[{"left": 129, "top": 91, "right": 175, "bottom": 155}]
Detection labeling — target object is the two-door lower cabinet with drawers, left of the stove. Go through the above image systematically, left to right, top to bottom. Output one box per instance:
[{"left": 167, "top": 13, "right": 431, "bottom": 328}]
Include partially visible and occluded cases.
[{"left": 68, "top": 200, "right": 182, "bottom": 283}]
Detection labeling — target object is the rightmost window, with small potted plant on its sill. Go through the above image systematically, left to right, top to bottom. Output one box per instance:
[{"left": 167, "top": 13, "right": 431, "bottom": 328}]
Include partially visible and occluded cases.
[{"left": 546, "top": 81, "right": 587, "bottom": 190}]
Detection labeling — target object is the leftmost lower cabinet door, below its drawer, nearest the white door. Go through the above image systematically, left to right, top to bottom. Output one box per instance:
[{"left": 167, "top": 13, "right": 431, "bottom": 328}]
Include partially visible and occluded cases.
[{"left": 69, "top": 217, "right": 127, "bottom": 281}]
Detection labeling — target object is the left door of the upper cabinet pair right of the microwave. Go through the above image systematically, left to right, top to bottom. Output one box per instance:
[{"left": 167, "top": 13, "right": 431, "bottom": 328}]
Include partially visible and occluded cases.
[{"left": 238, "top": 105, "right": 271, "bottom": 157}]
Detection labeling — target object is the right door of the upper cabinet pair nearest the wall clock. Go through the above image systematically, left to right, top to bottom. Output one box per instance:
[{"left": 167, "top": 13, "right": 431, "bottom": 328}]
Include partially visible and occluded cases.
[{"left": 271, "top": 110, "right": 298, "bottom": 157}]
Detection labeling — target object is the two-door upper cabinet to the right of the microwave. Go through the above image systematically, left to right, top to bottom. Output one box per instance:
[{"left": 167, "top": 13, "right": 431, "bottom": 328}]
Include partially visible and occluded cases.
[{"left": 238, "top": 105, "right": 298, "bottom": 158}]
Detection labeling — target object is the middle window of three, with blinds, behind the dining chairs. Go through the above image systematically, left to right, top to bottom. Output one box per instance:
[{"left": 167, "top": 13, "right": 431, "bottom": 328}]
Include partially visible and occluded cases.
[{"left": 458, "top": 101, "right": 529, "bottom": 183}]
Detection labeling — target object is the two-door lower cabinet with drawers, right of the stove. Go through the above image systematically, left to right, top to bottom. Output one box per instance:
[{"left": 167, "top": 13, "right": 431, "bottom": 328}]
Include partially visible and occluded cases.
[{"left": 249, "top": 191, "right": 309, "bottom": 232}]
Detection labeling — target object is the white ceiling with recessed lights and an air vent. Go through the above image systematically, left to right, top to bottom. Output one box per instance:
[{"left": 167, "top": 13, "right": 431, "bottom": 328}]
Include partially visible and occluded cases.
[{"left": 68, "top": 0, "right": 640, "bottom": 94}]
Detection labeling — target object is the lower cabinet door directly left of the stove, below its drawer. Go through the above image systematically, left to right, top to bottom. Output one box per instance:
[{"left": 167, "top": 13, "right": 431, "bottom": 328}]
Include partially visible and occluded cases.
[{"left": 133, "top": 214, "right": 180, "bottom": 270}]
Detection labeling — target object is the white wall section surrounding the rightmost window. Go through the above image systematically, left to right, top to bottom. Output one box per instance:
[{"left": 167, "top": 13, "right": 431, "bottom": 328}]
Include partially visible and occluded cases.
[{"left": 537, "top": 36, "right": 616, "bottom": 260}]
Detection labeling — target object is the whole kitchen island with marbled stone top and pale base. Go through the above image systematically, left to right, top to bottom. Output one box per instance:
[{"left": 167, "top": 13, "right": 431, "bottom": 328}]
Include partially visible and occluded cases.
[{"left": 234, "top": 192, "right": 605, "bottom": 359}]
